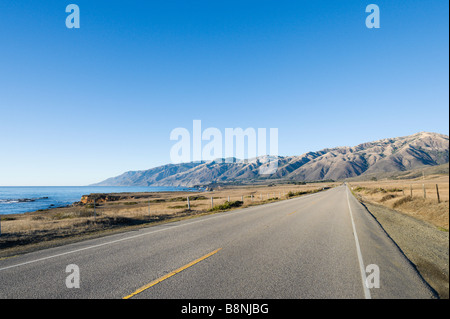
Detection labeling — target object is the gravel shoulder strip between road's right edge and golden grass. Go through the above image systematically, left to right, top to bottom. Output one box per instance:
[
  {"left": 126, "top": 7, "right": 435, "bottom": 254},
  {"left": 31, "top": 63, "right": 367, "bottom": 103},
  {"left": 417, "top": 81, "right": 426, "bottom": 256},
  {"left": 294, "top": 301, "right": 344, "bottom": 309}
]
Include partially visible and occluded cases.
[{"left": 361, "top": 201, "right": 449, "bottom": 299}]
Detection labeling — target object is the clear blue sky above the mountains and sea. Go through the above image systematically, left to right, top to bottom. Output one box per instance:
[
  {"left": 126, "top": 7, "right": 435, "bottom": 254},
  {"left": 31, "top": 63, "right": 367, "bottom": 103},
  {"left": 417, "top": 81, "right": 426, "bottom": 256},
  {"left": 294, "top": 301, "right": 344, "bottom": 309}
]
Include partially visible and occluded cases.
[{"left": 0, "top": 0, "right": 449, "bottom": 186}]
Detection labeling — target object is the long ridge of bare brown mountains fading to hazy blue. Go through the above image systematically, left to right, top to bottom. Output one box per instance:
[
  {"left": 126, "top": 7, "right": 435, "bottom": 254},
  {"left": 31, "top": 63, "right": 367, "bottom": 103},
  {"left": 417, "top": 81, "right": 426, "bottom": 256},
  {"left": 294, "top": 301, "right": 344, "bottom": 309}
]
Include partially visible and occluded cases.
[{"left": 94, "top": 132, "right": 449, "bottom": 186}]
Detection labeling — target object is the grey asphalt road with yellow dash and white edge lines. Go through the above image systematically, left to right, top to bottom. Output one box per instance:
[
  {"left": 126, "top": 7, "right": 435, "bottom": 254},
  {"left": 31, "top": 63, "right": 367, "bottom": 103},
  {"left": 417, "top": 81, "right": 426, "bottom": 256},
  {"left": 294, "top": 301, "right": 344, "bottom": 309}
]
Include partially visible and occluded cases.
[{"left": 0, "top": 185, "right": 435, "bottom": 299}]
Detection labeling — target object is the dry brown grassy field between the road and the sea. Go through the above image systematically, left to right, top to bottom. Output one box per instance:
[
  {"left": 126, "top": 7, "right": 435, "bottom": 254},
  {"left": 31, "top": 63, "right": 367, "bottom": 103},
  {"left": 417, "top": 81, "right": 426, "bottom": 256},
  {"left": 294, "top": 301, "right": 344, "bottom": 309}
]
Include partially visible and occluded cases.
[{"left": 0, "top": 183, "right": 337, "bottom": 257}]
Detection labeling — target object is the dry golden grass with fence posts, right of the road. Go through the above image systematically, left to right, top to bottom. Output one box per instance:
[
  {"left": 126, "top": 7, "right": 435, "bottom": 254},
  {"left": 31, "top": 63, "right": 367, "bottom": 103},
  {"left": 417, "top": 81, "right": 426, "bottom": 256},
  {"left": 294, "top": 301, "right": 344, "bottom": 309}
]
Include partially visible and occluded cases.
[{"left": 350, "top": 175, "right": 449, "bottom": 230}]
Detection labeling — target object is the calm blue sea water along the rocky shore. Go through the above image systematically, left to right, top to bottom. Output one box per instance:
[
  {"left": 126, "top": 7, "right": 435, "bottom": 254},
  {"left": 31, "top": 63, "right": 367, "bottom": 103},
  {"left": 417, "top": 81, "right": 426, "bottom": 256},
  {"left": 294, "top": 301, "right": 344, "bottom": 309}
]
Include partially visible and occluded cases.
[{"left": 0, "top": 186, "right": 193, "bottom": 215}]
